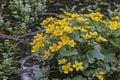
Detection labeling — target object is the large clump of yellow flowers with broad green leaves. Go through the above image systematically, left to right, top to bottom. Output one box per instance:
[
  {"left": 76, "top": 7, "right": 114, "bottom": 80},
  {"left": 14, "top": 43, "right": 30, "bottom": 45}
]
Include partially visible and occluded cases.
[{"left": 31, "top": 12, "right": 120, "bottom": 80}]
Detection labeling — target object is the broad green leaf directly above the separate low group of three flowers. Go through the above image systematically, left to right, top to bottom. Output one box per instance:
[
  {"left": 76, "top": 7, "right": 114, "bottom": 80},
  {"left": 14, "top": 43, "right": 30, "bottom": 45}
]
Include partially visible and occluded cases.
[{"left": 59, "top": 47, "right": 78, "bottom": 56}]
